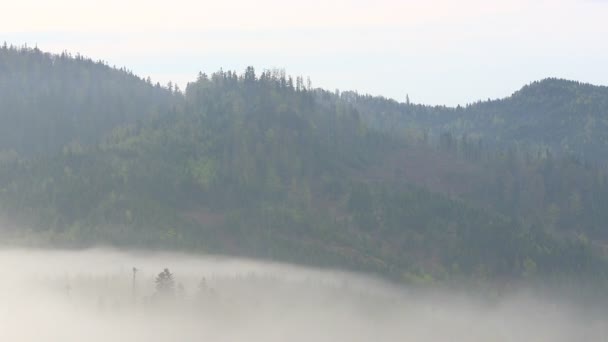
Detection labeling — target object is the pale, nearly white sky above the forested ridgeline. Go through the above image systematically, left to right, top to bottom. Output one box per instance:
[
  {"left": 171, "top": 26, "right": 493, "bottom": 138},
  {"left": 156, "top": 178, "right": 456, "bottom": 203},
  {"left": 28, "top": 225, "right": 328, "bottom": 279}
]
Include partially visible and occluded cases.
[{"left": 0, "top": 0, "right": 608, "bottom": 105}]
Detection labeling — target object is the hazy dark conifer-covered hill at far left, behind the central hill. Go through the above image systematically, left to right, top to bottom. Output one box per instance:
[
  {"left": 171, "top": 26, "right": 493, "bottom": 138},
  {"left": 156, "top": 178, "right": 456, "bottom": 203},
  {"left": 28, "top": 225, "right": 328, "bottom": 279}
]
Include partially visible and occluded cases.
[{"left": 0, "top": 44, "right": 174, "bottom": 155}]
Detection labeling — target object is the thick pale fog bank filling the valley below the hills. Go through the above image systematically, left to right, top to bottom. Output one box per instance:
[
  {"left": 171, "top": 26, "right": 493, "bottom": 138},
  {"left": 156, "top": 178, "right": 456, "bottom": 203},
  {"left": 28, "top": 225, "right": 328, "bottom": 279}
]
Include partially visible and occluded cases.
[{"left": 0, "top": 249, "right": 608, "bottom": 342}]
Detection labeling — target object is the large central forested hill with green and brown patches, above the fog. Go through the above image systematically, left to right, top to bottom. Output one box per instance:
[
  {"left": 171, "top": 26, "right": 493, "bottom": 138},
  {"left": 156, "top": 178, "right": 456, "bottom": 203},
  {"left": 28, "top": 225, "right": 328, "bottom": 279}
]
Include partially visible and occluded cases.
[{"left": 0, "top": 68, "right": 604, "bottom": 281}]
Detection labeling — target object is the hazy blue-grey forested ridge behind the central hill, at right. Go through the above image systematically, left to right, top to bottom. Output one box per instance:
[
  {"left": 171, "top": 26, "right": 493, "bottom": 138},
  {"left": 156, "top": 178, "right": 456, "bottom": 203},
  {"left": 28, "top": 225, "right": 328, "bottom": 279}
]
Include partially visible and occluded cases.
[{"left": 339, "top": 79, "right": 608, "bottom": 162}]
